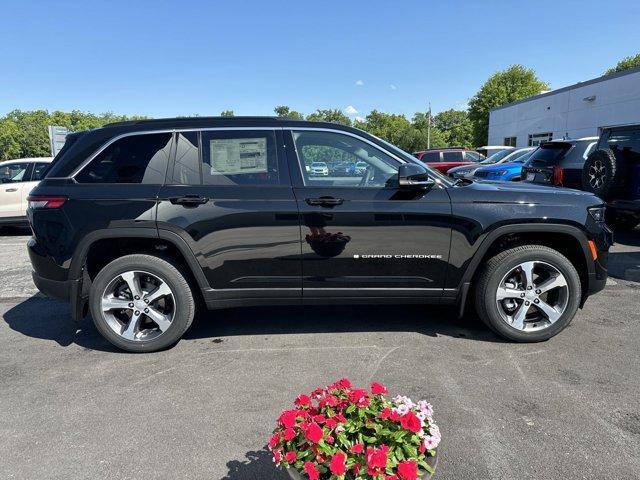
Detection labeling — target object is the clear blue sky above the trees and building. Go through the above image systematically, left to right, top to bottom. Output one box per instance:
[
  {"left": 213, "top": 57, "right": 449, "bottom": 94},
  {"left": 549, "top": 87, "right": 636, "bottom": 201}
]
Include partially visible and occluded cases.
[{"left": 0, "top": 0, "right": 640, "bottom": 117}]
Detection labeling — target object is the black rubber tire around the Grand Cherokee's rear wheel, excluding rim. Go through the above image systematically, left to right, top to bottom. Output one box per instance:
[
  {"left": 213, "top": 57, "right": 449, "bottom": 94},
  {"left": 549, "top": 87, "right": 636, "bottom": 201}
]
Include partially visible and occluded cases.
[{"left": 89, "top": 254, "right": 195, "bottom": 352}]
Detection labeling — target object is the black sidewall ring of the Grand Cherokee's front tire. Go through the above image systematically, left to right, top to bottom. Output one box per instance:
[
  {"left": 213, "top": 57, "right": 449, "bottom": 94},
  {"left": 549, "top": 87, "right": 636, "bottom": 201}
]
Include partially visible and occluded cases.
[{"left": 483, "top": 250, "right": 582, "bottom": 342}]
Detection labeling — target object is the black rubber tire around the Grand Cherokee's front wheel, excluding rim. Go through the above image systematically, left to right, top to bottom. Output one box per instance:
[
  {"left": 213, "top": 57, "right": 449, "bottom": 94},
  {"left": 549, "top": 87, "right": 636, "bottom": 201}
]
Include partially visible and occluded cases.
[{"left": 475, "top": 245, "right": 582, "bottom": 342}]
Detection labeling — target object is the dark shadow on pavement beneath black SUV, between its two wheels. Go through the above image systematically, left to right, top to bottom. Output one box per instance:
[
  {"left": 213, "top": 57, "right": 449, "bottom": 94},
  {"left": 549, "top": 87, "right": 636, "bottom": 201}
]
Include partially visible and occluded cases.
[{"left": 184, "top": 305, "right": 503, "bottom": 342}]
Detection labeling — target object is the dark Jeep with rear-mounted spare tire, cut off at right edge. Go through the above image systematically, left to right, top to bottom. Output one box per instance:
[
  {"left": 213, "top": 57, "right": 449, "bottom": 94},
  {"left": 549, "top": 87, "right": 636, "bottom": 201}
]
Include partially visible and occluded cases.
[{"left": 581, "top": 125, "right": 640, "bottom": 229}]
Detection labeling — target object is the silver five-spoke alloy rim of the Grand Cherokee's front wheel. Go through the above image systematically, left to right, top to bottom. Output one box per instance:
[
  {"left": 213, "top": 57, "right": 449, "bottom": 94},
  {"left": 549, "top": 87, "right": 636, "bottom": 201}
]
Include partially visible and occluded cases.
[{"left": 495, "top": 261, "right": 569, "bottom": 332}]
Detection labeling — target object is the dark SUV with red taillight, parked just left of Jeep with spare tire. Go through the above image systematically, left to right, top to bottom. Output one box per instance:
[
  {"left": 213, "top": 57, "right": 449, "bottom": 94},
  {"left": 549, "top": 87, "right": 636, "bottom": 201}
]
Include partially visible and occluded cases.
[{"left": 522, "top": 137, "right": 598, "bottom": 189}]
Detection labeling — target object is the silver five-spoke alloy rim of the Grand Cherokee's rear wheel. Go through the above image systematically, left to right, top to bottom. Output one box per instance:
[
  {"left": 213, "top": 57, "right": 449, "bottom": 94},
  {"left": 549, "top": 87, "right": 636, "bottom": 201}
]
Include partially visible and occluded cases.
[{"left": 100, "top": 270, "right": 176, "bottom": 342}]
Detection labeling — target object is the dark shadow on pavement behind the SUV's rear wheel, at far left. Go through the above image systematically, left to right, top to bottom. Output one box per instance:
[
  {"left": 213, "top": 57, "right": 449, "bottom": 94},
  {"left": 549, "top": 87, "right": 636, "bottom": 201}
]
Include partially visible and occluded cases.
[{"left": 3, "top": 295, "right": 119, "bottom": 352}]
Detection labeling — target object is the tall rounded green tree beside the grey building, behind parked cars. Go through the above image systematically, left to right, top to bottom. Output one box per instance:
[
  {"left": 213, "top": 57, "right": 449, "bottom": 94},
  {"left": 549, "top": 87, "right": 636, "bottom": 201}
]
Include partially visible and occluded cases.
[{"left": 469, "top": 65, "right": 549, "bottom": 146}]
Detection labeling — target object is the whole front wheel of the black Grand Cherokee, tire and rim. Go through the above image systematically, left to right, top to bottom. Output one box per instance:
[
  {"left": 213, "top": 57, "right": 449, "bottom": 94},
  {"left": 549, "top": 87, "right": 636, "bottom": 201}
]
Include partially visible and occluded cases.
[{"left": 475, "top": 245, "right": 581, "bottom": 342}]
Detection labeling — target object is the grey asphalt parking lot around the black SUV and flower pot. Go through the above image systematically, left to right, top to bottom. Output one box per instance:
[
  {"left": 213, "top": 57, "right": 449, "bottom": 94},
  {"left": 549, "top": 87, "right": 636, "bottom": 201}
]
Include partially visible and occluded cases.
[{"left": 0, "top": 227, "right": 640, "bottom": 479}]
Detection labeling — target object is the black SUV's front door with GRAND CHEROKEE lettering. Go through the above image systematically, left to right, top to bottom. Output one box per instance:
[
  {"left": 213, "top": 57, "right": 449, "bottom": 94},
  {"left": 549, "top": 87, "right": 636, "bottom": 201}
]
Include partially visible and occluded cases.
[{"left": 287, "top": 129, "right": 451, "bottom": 298}]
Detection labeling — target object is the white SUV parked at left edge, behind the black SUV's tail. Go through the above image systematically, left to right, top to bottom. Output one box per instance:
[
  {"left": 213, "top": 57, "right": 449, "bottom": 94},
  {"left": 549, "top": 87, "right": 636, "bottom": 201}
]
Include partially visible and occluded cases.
[{"left": 0, "top": 157, "right": 53, "bottom": 227}]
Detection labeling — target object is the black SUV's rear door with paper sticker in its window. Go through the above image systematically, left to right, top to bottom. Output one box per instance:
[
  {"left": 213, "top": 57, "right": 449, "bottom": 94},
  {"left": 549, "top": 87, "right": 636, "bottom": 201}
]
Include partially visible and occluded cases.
[{"left": 157, "top": 128, "right": 302, "bottom": 301}]
